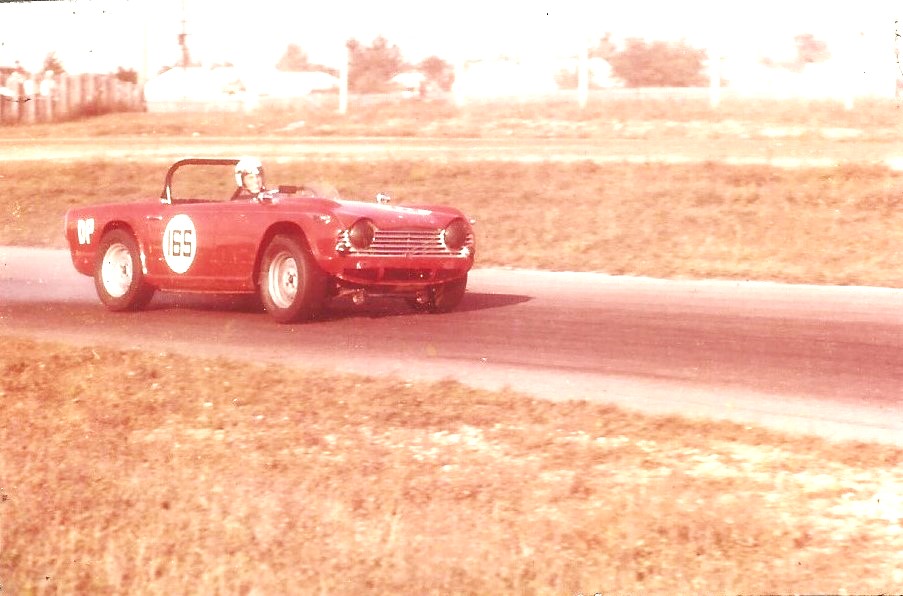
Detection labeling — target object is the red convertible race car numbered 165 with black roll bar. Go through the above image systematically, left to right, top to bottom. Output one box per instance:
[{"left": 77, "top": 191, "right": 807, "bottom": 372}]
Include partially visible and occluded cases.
[{"left": 65, "top": 158, "right": 475, "bottom": 323}]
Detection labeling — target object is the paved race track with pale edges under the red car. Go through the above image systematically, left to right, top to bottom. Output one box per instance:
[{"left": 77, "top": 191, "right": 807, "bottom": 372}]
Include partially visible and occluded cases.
[{"left": 0, "top": 247, "right": 903, "bottom": 445}]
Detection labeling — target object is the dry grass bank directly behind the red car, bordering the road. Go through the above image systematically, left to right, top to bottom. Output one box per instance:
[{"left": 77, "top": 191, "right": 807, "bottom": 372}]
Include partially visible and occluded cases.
[{"left": 0, "top": 162, "right": 903, "bottom": 287}]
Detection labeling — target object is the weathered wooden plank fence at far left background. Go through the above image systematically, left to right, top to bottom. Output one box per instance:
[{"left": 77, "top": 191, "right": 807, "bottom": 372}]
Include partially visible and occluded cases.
[{"left": 0, "top": 73, "right": 144, "bottom": 125}]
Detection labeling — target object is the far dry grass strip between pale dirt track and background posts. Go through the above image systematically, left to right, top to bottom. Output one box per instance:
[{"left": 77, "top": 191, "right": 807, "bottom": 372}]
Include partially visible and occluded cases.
[{"left": 0, "top": 93, "right": 903, "bottom": 142}]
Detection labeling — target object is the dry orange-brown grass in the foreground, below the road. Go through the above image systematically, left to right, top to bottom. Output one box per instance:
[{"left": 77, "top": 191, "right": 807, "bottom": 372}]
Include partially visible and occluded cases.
[{"left": 0, "top": 337, "right": 903, "bottom": 594}]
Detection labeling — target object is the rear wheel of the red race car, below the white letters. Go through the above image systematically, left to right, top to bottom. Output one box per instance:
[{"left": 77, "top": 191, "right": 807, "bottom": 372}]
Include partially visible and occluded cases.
[{"left": 94, "top": 230, "right": 154, "bottom": 311}]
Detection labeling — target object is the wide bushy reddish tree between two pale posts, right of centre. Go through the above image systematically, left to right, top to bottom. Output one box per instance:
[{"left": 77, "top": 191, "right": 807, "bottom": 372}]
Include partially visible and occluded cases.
[{"left": 608, "top": 38, "right": 707, "bottom": 87}]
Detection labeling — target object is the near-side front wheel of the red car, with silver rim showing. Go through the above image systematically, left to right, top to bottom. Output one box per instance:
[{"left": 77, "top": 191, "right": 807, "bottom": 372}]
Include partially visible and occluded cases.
[{"left": 258, "top": 235, "right": 326, "bottom": 323}]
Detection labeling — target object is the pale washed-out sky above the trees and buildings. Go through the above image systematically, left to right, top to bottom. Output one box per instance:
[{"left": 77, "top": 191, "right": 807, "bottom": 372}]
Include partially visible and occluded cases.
[{"left": 0, "top": 0, "right": 903, "bottom": 75}]
